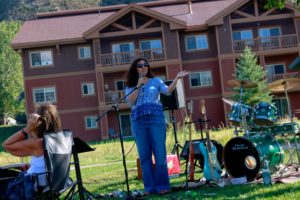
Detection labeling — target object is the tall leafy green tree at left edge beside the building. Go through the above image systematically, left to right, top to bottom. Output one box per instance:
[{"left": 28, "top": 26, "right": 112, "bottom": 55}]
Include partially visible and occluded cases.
[{"left": 0, "top": 21, "right": 24, "bottom": 123}]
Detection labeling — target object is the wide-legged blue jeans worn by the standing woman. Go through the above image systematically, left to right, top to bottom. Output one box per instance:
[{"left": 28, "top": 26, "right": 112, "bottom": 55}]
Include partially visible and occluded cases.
[{"left": 131, "top": 115, "right": 170, "bottom": 193}]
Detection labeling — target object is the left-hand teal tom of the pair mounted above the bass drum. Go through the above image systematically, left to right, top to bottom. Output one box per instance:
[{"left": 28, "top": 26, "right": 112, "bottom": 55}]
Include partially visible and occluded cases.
[{"left": 229, "top": 103, "right": 252, "bottom": 126}]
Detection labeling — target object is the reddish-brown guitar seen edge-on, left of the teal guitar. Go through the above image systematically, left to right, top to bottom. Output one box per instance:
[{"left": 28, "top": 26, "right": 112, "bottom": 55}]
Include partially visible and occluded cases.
[{"left": 188, "top": 101, "right": 195, "bottom": 181}]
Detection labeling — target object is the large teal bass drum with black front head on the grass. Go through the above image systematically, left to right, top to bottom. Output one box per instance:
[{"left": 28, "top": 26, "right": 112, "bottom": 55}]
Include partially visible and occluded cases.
[{"left": 223, "top": 133, "right": 284, "bottom": 181}]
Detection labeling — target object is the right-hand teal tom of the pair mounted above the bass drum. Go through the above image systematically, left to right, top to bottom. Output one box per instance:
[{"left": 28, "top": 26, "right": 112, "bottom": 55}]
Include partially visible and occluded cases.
[{"left": 253, "top": 102, "right": 277, "bottom": 126}]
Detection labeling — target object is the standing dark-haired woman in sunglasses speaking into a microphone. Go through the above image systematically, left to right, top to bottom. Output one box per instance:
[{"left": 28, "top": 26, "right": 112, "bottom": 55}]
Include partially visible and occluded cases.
[{"left": 126, "top": 58, "right": 189, "bottom": 195}]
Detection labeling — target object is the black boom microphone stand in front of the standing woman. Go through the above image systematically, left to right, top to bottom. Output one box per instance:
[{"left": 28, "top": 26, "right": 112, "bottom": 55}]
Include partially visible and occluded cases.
[{"left": 96, "top": 87, "right": 141, "bottom": 199}]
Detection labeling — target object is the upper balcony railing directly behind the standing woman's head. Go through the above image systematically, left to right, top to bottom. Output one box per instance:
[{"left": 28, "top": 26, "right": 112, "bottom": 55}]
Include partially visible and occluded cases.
[{"left": 100, "top": 49, "right": 165, "bottom": 66}]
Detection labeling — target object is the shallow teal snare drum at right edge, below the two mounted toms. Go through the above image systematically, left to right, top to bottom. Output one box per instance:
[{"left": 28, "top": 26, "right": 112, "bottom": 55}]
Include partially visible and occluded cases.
[{"left": 271, "top": 122, "right": 300, "bottom": 135}]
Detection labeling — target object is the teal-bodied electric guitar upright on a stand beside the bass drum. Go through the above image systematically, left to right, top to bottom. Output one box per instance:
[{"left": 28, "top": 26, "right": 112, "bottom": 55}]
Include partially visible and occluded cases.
[{"left": 200, "top": 99, "right": 222, "bottom": 182}]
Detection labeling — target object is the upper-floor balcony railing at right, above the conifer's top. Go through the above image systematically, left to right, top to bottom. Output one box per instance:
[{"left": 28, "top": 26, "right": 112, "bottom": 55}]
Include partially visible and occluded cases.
[{"left": 233, "top": 34, "right": 298, "bottom": 53}]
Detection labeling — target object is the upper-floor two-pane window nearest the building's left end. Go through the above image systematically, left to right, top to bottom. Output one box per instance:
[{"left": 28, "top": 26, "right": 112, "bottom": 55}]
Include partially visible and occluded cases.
[{"left": 30, "top": 50, "right": 53, "bottom": 67}]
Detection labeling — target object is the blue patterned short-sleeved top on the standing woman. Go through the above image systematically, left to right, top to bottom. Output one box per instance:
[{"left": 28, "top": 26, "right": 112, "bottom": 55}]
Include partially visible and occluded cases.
[{"left": 126, "top": 77, "right": 171, "bottom": 120}]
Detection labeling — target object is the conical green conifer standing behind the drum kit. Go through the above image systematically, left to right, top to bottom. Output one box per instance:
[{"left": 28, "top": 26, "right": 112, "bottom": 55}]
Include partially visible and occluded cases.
[{"left": 234, "top": 47, "right": 272, "bottom": 106}]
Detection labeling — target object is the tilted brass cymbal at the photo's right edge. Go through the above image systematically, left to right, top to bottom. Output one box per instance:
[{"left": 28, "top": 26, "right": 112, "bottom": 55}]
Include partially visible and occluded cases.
[{"left": 268, "top": 78, "right": 300, "bottom": 93}]
